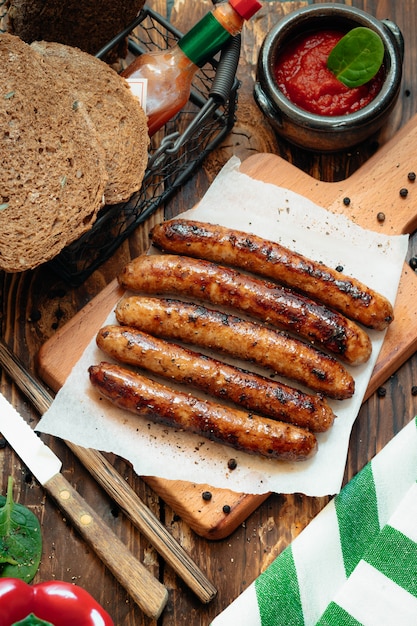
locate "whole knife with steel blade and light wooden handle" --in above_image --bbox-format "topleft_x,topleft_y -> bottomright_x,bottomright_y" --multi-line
0,394 -> 168,619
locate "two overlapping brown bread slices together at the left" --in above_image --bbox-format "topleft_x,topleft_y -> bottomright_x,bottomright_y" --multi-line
0,33 -> 149,272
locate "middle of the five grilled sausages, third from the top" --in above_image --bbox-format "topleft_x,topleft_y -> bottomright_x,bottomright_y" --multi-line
116,296 -> 355,400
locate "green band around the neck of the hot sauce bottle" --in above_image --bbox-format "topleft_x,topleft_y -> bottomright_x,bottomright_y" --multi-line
178,13 -> 231,66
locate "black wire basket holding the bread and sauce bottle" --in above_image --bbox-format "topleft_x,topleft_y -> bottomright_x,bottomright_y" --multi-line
37,7 -> 240,286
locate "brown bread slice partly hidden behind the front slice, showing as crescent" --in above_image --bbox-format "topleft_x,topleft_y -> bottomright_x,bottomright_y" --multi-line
31,41 -> 149,204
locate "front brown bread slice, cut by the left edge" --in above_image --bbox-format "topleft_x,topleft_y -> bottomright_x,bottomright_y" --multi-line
0,33 -> 107,272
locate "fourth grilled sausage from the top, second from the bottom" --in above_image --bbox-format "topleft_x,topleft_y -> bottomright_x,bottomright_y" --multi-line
96,325 -> 335,432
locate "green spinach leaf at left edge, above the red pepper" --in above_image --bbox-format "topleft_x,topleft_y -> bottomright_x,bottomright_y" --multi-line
0,476 -> 42,582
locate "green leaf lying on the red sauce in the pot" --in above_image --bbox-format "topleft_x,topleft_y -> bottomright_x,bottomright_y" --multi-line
327,26 -> 384,87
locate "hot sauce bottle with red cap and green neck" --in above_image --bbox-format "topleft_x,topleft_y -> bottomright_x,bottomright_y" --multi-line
122,0 -> 262,136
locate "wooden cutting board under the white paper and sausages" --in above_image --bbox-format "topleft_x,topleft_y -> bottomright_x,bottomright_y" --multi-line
38,116 -> 417,539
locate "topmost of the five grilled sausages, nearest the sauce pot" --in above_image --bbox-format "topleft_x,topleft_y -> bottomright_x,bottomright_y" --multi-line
150,219 -> 394,330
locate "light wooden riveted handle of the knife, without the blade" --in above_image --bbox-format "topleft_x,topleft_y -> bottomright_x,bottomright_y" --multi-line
43,474 -> 168,619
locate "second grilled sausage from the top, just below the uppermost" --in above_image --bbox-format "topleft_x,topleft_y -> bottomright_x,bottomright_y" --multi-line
119,254 -> 372,365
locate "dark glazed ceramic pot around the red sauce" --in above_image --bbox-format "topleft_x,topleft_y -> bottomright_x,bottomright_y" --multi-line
254,3 -> 404,152
